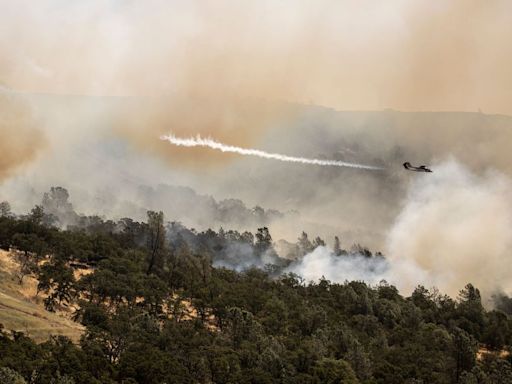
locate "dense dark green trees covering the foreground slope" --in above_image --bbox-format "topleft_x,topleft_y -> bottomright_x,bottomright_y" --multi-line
0,190 -> 512,384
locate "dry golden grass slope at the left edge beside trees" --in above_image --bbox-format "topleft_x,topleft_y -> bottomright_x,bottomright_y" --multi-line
0,251 -> 83,342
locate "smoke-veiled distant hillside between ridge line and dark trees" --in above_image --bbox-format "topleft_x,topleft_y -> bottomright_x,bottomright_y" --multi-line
4,94 -> 512,250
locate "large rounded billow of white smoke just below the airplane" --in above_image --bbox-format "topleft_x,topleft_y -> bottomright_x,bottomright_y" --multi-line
387,161 -> 512,295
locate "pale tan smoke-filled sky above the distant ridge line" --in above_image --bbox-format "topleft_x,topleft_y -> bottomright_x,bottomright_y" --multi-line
0,0 -> 512,114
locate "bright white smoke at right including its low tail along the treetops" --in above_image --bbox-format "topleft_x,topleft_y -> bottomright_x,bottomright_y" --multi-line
289,161 -> 512,298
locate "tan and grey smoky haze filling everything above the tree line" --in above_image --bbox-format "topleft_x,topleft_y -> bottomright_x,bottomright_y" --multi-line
0,0 -> 512,292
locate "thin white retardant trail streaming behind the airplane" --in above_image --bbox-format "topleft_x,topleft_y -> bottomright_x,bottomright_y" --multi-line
160,134 -> 383,171
